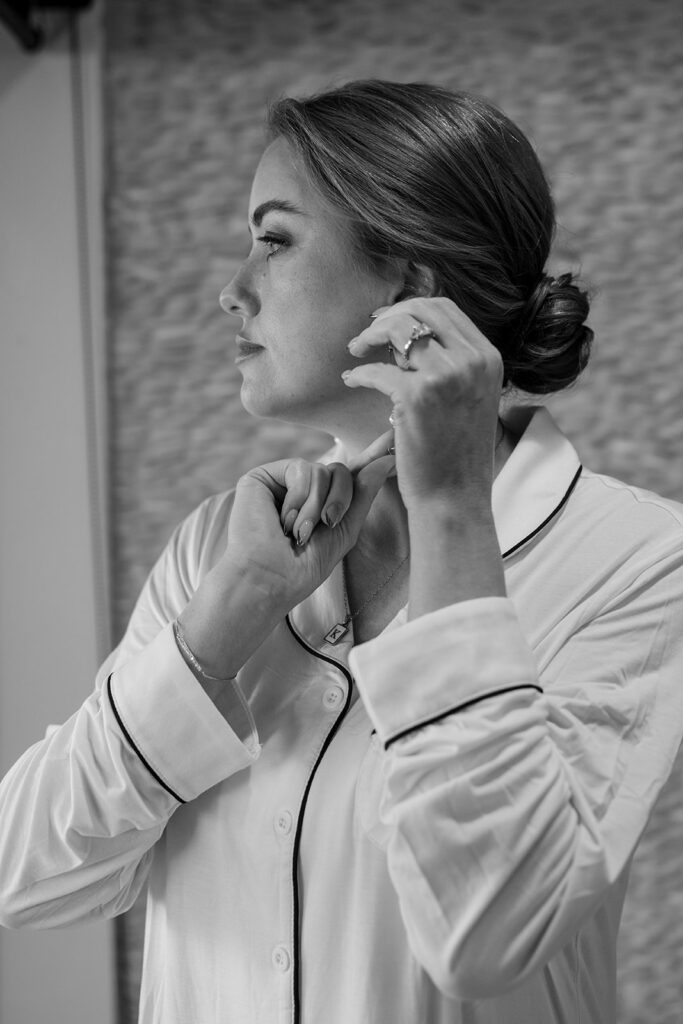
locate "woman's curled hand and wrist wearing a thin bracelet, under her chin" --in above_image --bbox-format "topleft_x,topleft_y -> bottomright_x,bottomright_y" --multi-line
179,431 -> 395,679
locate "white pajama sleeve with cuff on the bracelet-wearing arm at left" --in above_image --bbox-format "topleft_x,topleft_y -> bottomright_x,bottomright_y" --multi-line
0,491 -> 259,927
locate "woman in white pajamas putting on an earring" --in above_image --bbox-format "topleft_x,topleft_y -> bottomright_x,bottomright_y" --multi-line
0,82 -> 683,1024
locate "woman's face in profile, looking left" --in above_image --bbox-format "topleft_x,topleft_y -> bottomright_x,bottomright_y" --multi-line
220,138 -> 402,435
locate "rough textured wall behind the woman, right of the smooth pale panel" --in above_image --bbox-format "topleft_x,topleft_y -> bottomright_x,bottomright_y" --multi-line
105,0 -> 683,1024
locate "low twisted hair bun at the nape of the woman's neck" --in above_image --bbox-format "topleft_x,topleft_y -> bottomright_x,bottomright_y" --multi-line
505,273 -> 593,394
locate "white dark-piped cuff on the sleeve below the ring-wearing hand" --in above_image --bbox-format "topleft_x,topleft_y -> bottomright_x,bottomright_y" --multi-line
349,597 -> 541,745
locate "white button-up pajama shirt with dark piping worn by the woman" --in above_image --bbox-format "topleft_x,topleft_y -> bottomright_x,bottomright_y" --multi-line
0,409 -> 683,1024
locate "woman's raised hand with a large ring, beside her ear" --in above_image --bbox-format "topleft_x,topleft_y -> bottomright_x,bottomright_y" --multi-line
342,297 -> 503,512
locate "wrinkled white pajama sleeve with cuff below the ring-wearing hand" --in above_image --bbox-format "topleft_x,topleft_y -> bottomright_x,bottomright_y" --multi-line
351,534 -> 683,999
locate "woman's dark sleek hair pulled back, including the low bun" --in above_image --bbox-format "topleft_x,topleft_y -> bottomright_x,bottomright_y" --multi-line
268,80 -> 593,394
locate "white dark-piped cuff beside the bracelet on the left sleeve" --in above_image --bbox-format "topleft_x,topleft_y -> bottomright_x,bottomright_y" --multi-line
110,623 -> 260,801
